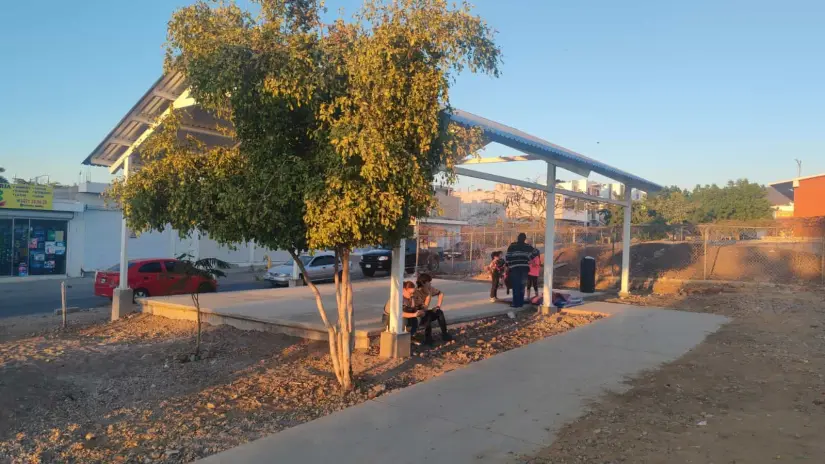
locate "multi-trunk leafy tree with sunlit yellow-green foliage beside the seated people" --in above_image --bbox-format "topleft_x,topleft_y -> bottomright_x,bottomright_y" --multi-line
107,0 -> 500,389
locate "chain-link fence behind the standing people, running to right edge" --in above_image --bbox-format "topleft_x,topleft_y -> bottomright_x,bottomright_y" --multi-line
418,219 -> 825,288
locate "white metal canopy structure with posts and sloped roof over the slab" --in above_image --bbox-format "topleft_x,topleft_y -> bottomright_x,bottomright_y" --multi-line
83,73 -> 662,358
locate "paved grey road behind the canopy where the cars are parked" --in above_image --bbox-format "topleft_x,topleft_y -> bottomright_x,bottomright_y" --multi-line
0,268 -> 364,318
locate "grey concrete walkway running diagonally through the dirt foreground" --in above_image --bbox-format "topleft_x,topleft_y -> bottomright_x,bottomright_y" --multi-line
200,302 -> 727,464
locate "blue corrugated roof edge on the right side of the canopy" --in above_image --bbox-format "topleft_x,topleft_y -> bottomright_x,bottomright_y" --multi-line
448,109 -> 662,193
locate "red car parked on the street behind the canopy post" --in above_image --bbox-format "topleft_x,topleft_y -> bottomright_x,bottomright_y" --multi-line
95,258 -> 218,298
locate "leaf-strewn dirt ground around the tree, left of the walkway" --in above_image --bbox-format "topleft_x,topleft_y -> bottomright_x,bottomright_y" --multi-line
0,311 -> 595,463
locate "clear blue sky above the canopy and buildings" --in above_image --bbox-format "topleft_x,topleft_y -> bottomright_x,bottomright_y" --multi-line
0,0 -> 825,187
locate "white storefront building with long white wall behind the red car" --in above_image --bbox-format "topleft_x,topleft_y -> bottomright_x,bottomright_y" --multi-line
0,182 -> 289,278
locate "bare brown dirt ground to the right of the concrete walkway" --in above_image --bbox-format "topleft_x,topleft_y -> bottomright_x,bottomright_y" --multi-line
529,287 -> 825,464
